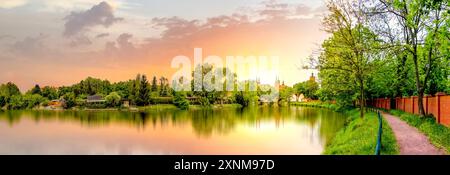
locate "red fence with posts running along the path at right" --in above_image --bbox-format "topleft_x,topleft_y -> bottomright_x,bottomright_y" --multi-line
368,93 -> 450,126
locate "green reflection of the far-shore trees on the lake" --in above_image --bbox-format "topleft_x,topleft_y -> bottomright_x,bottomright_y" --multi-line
0,107 -> 345,141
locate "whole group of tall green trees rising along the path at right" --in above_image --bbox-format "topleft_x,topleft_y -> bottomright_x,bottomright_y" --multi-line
311,0 -> 450,117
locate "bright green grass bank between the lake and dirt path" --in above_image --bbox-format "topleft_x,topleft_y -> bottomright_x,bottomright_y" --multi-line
323,109 -> 399,155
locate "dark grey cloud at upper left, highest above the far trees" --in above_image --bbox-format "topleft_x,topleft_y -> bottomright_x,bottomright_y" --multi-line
63,1 -> 123,37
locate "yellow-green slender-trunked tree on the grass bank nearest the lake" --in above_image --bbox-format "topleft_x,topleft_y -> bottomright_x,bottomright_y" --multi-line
319,1 -> 378,117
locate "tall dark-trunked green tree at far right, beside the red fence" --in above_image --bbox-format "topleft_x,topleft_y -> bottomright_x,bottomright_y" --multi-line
373,0 -> 450,116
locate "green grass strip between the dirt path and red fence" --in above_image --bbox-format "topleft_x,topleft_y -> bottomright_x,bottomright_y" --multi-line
389,110 -> 450,154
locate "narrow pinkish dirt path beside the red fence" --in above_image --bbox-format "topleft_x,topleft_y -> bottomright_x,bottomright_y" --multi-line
383,113 -> 444,155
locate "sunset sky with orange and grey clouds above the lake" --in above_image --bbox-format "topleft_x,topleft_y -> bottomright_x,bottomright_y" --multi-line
0,0 -> 327,91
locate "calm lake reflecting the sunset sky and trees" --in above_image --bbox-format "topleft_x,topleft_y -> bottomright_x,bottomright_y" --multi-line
0,106 -> 346,155
